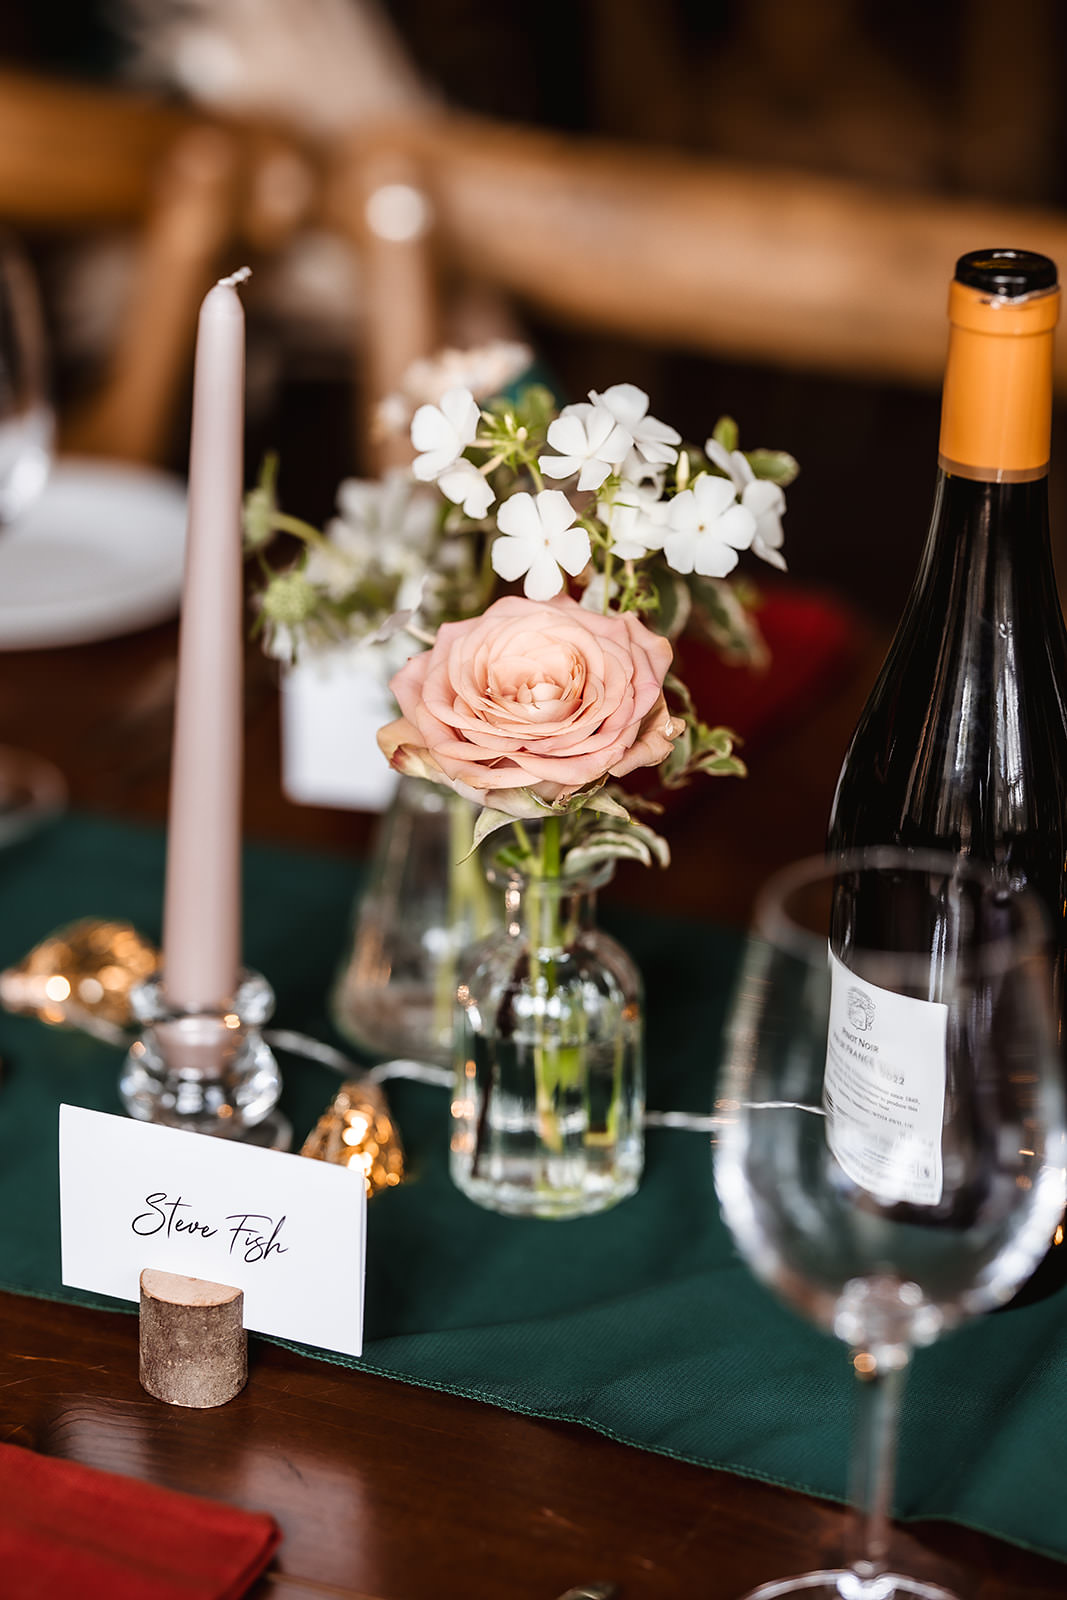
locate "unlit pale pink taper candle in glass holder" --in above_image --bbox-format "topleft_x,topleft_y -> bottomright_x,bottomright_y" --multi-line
163,269 -> 248,1011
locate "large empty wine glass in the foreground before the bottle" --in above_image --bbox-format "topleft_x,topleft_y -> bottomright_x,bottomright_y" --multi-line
715,848 -> 1067,1600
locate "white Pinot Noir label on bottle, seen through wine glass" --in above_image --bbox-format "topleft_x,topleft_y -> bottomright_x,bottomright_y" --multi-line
822,950 -> 949,1205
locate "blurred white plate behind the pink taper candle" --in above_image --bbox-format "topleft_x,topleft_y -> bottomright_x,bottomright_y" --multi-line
0,461 -> 186,650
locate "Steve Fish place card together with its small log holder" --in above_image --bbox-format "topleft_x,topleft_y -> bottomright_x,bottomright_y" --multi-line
59,1106 -> 366,1406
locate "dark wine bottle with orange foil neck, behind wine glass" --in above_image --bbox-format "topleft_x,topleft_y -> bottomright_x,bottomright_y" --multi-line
829,250 -> 1067,1298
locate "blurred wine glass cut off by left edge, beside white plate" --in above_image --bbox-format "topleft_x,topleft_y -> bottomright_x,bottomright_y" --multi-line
0,229 -> 66,846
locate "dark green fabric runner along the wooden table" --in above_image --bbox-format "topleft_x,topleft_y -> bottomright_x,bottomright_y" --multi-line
0,818 -> 1067,1560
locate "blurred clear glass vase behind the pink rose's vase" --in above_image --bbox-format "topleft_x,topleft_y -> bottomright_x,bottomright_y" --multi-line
330,778 -> 501,1066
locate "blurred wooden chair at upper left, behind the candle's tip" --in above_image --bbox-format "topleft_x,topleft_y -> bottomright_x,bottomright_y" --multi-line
0,72 -> 317,464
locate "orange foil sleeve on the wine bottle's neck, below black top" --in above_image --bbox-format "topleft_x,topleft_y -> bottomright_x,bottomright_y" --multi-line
939,283 -> 1059,483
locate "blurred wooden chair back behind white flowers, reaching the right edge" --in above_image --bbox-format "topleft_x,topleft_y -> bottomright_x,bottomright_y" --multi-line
326,115 -> 1067,464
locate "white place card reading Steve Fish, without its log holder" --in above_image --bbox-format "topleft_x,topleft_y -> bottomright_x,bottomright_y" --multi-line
59,1106 -> 366,1355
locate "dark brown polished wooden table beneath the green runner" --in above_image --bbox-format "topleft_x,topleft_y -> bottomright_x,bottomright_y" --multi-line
0,627 -> 1067,1600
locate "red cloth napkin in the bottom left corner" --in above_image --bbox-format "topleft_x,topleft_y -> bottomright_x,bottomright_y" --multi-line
0,1445 -> 282,1600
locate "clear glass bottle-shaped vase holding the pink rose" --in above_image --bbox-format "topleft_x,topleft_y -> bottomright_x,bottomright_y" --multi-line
451,862 -> 645,1218
